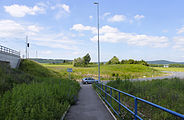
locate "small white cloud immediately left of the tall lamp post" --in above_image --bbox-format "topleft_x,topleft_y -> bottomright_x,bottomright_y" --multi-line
71,24 -> 97,33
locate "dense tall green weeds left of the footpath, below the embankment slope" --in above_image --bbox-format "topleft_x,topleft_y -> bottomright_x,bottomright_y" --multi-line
0,79 -> 80,120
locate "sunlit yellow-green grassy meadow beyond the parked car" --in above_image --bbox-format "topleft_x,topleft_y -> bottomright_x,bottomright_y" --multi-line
43,64 -> 163,80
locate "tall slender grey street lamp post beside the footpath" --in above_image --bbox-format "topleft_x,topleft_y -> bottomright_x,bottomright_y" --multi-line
94,2 -> 100,82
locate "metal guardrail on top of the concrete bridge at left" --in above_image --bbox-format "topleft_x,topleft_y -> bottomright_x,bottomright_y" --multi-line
0,45 -> 20,56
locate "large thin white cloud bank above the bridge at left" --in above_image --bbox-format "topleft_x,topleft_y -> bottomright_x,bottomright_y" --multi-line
0,20 -> 79,50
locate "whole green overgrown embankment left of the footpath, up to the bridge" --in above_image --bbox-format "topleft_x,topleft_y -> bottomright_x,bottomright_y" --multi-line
0,60 -> 80,120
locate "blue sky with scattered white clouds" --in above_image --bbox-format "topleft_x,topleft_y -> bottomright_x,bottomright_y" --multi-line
0,0 -> 184,62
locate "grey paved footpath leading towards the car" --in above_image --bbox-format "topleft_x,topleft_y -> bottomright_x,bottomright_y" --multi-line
65,85 -> 114,120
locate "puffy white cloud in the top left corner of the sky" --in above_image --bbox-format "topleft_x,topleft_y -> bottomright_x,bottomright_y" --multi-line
4,4 -> 45,17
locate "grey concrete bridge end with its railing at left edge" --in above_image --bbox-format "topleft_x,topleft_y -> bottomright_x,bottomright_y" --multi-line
0,45 -> 21,68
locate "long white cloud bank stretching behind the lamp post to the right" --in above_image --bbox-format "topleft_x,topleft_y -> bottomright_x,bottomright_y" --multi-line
72,24 -> 169,47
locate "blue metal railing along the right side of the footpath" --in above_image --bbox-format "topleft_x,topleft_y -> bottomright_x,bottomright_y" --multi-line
95,83 -> 184,120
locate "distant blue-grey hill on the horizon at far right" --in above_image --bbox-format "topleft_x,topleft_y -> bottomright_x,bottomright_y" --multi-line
146,60 -> 184,64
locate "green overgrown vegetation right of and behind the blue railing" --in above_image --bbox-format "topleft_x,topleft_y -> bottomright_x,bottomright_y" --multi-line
98,78 -> 184,120
